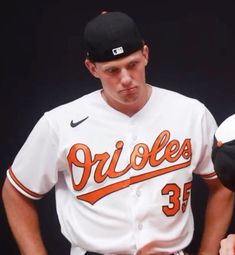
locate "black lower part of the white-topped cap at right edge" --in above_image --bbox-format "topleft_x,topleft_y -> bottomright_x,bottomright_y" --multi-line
212,138 -> 235,191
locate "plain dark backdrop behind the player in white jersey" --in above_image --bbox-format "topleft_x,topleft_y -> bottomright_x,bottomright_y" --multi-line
0,0 -> 235,255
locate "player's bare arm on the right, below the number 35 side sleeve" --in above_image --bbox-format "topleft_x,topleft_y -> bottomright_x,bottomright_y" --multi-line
198,179 -> 234,255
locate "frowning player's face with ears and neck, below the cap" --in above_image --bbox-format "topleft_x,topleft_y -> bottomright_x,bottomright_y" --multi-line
85,45 -> 148,114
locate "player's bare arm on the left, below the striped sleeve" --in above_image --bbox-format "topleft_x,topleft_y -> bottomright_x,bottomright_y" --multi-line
2,178 -> 47,255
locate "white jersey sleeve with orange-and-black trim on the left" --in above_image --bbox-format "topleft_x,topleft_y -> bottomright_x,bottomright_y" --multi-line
7,115 -> 58,199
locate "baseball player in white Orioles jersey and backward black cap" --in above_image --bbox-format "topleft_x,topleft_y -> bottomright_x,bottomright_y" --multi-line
3,12 -> 233,255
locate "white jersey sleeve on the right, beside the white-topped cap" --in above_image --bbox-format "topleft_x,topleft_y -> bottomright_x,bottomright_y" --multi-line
194,107 -> 218,179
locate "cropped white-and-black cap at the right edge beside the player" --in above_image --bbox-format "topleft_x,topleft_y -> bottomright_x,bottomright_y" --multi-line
212,114 -> 235,191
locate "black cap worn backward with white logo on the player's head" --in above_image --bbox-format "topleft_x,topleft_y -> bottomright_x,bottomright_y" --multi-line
84,12 -> 144,62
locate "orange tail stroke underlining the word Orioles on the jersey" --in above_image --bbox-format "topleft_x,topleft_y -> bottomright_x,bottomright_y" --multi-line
77,160 -> 191,204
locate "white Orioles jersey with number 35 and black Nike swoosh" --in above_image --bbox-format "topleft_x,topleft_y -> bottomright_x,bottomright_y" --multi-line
7,87 -> 217,255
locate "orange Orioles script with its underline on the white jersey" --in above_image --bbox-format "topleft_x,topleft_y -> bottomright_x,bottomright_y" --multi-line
67,130 -> 192,204
